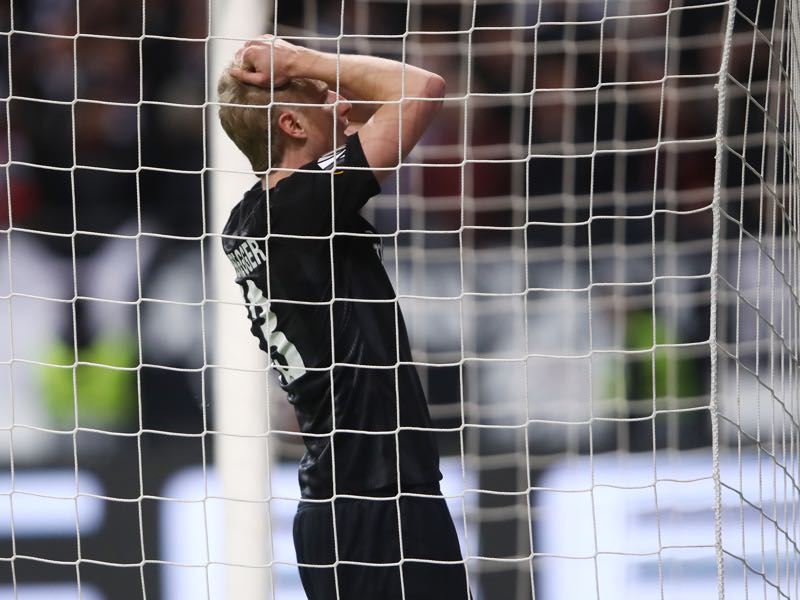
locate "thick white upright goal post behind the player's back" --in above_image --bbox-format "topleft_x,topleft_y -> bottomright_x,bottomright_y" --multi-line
207,0 -> 272,600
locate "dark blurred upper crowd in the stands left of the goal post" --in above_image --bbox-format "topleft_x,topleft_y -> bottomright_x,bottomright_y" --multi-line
3,0 -> 207,244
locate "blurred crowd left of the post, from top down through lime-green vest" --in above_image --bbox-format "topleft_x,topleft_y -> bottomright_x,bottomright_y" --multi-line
0,0 -> 208,447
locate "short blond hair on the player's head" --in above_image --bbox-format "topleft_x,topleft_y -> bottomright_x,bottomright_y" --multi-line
217,67 -> 316,173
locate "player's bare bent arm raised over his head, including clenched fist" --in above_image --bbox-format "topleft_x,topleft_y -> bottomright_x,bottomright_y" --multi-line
231,36 -> 445,180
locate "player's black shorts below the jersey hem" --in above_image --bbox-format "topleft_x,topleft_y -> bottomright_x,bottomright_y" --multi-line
294,484 -> 470,600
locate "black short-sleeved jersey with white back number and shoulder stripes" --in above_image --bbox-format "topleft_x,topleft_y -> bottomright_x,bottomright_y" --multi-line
222,135 -> 441,498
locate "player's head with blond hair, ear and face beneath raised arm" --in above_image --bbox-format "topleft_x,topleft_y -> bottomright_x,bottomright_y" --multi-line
217,69 -> 351,173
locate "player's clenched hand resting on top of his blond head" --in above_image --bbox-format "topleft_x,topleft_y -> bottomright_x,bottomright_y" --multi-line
230,34 -> 299,88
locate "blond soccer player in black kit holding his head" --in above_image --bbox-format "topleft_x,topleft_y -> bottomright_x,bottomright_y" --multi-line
219,36 -> 469,600
